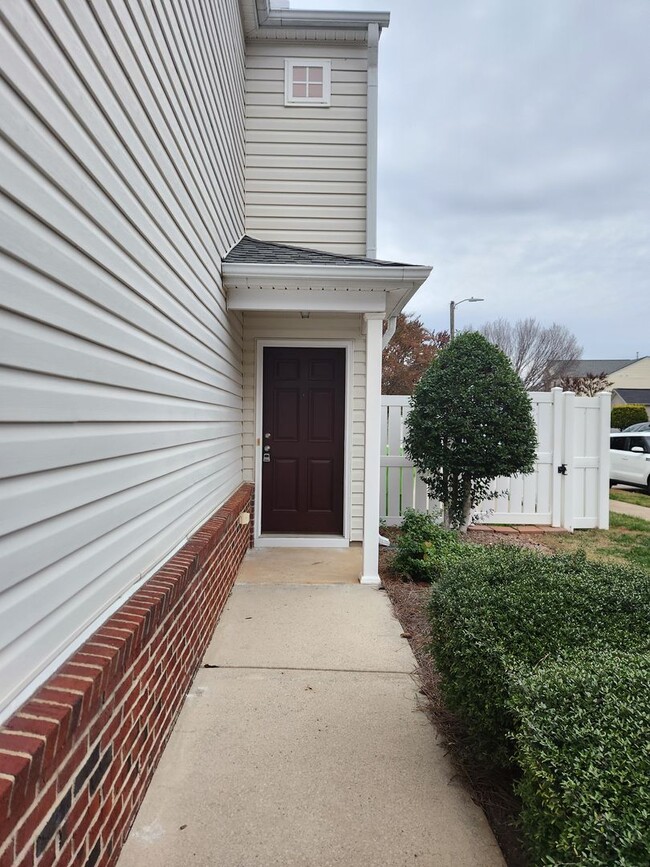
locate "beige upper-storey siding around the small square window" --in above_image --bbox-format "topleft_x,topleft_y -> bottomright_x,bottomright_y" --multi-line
246,42 -> 367,255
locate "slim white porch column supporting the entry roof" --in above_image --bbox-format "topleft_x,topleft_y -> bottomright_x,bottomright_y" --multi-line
360,313 -> 384,585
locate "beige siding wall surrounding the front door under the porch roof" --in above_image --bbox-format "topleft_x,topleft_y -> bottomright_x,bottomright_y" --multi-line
244,312 -> 366,542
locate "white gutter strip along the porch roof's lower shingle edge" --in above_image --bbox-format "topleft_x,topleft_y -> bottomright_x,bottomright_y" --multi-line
222,262 -> 431,292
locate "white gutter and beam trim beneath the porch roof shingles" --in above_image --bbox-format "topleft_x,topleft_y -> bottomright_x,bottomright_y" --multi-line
222,262 -> 431,318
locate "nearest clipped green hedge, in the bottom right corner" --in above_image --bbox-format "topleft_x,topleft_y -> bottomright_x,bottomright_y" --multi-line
513,651 -> 650,867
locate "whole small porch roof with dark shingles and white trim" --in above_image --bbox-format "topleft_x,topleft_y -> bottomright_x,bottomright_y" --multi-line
222,235 -> 431,317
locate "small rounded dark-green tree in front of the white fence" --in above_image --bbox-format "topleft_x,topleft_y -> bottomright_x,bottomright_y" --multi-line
404,332 -> 537,532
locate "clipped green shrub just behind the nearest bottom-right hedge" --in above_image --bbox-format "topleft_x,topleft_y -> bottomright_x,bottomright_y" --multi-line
430,545 -> 650,765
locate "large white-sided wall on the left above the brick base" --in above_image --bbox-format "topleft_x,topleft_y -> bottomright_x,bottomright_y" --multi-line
0,0 -> 244,713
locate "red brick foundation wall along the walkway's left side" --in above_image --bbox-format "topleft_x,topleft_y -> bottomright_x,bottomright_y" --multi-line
0,485 -> 253,867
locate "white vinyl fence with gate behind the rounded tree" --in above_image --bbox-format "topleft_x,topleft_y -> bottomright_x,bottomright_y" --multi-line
380,388 -> 611,530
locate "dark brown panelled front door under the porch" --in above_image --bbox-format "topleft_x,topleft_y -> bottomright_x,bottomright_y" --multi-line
262,347 -> 345,534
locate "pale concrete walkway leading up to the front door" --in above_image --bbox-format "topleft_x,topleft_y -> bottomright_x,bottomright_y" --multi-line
119,549 -> 504,867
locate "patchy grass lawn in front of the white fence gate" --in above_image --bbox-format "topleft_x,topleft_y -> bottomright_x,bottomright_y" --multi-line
543,512 -> 650,571
